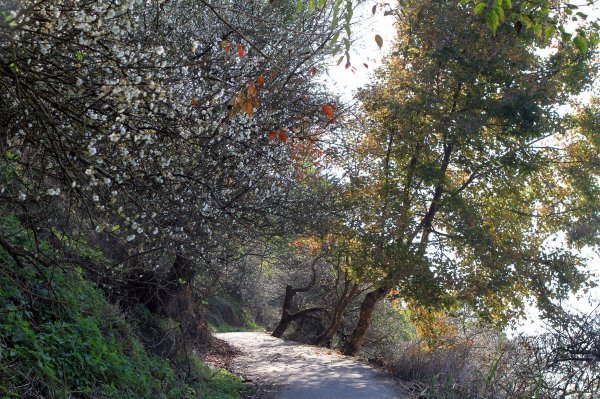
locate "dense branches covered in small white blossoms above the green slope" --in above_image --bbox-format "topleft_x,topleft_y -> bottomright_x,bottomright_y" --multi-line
0,0 -> 330,282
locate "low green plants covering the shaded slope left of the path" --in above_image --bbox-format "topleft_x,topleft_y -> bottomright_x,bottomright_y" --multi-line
0,215 -> 243,399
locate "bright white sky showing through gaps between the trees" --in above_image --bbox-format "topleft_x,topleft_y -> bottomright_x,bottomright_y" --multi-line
327,0 -> 600,334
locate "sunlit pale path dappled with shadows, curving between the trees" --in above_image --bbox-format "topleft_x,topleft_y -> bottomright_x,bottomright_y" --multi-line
216,332 -> 408,399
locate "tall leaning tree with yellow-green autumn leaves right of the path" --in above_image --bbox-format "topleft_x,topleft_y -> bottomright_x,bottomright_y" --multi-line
341,0 -> 599,355
